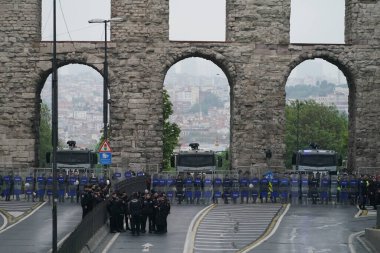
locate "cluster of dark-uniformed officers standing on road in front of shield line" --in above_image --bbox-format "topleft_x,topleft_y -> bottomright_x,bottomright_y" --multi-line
107,190 -> 170,235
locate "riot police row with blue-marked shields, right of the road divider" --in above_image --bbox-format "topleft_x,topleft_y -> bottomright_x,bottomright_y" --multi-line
152,172 -> 376,204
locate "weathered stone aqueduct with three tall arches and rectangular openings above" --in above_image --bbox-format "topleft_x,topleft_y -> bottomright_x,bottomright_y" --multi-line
0,0 -> 380,172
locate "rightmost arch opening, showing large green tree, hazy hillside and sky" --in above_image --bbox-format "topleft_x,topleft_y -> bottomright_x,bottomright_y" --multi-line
285,57 -> 355,170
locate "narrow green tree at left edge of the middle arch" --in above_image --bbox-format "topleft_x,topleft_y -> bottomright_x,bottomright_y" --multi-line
163,90 -> 181,170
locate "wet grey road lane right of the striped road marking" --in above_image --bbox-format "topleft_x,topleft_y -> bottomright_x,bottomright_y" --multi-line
249,205 -> 376,253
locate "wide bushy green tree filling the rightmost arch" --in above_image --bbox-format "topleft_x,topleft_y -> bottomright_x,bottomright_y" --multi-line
285,100 -> 348,168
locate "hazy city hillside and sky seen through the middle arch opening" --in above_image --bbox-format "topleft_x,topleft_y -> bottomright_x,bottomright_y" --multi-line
164,57 -> 231,170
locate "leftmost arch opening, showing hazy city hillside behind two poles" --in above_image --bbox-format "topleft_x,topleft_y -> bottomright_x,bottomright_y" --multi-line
36,64 -> 104,167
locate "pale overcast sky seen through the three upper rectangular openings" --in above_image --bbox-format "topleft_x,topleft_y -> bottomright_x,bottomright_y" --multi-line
42,0 -> 345,43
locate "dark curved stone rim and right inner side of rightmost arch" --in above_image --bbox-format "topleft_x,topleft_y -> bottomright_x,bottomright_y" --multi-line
282,51 -> 356,170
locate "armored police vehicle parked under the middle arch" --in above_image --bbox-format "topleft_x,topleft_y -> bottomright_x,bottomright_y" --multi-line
172,143 -> 222,173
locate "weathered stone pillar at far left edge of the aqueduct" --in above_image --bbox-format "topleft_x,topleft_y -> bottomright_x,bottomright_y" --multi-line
0,0 -> 41,166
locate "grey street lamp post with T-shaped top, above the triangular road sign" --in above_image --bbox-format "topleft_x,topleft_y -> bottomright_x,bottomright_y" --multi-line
88,18 -> 123,141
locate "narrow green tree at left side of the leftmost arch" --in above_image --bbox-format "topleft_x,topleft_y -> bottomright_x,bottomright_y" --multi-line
39,103 -> 53,167
